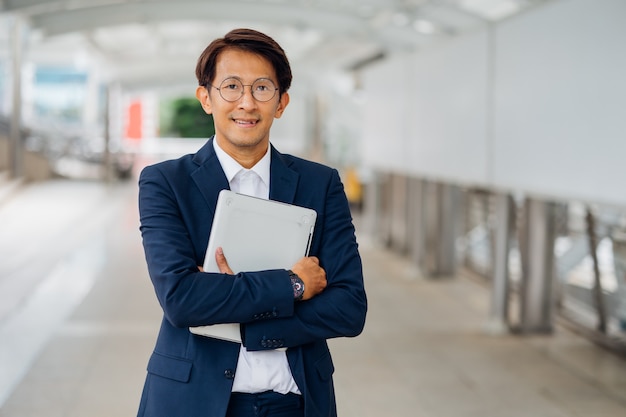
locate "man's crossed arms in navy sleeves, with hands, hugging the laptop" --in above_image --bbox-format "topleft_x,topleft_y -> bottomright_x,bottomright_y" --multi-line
140,164 -> 367,350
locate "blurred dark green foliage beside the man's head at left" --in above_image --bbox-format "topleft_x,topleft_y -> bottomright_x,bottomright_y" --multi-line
161,97 -> 215,138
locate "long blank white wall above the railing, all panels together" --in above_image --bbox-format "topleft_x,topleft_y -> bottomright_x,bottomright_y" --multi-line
363,0 -> 626,205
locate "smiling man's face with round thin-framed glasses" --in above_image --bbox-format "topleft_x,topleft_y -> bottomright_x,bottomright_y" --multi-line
196,49 -> 289,159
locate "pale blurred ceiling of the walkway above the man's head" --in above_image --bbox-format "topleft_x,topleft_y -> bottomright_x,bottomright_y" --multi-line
0,0 -> 547,88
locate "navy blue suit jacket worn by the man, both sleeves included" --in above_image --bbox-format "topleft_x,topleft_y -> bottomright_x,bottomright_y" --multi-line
139,139 -> 367,417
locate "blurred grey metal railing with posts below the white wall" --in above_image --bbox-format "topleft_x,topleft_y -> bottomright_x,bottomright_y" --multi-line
364,172 -> 626,353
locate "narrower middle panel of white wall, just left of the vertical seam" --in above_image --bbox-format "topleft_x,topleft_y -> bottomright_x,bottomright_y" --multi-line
404,28 -> 488,183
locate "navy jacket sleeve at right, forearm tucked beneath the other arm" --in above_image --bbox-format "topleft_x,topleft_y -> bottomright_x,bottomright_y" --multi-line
243,170 -> 367,350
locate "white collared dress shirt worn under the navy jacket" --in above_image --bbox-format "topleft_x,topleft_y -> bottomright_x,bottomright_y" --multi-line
213,139 -> 300,394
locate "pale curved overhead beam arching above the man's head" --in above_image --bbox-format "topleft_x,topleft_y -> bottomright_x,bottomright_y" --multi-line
19,0 -> 422,48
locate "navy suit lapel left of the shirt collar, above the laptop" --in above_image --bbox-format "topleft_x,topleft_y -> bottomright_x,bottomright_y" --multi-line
191,138 -> 230,214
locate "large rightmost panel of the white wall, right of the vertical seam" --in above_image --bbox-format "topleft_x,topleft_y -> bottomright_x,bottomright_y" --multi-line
493,0 -> 626,204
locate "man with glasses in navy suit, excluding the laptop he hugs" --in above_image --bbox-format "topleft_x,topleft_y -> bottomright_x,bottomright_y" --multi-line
134,29 -> 367,417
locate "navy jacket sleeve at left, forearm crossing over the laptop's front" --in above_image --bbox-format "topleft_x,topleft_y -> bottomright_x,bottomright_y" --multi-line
139,164 -> 294,327
